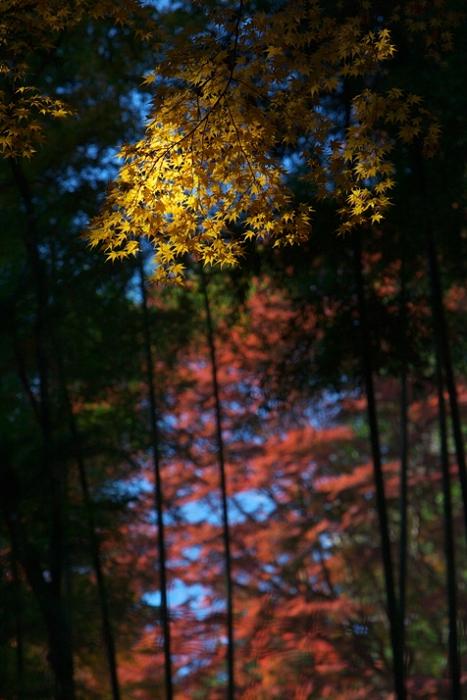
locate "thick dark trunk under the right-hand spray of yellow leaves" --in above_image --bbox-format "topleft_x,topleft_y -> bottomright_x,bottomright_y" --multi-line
353,231 -> 406,700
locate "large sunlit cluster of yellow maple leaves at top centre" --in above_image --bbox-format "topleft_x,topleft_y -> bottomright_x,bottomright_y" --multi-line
89,2 -> 402,282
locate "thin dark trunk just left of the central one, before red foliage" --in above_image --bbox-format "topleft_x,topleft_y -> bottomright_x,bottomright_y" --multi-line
139,256 -> 173,700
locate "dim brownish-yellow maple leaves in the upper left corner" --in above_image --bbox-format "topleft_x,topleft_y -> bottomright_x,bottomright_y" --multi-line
0,0 -> 157,158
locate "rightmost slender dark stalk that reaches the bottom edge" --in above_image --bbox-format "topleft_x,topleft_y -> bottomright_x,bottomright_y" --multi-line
436,353 -> 461,700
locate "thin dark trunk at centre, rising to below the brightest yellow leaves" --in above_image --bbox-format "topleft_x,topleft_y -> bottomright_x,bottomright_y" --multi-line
201,270 -> 235,700
